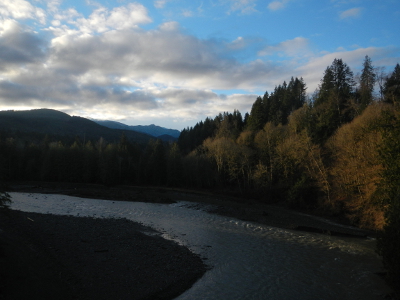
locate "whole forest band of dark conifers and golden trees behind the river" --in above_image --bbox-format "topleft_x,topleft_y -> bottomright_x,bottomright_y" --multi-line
0,56 -> 400,286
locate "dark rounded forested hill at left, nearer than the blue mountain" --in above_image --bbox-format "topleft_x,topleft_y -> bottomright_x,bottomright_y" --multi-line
0,109 -> 152,143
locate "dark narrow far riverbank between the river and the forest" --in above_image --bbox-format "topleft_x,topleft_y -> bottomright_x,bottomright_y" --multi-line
10,182 -> 377,238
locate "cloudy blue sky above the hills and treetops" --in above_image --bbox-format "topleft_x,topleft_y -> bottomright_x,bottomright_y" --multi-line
0,0 -> 400,130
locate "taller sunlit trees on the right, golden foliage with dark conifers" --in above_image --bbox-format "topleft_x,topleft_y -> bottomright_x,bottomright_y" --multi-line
178,56 -> 400,287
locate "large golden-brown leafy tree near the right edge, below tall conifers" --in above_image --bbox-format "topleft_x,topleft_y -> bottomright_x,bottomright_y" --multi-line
327,104 -> 384,229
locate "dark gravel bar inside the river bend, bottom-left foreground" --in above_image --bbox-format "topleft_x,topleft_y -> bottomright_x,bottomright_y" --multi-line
0,211 -> 206,299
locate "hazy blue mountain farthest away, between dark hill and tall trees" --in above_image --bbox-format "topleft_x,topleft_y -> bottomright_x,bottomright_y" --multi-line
93,120 -> 181,140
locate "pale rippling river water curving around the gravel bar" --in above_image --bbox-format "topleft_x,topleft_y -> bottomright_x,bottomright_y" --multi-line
10,193 -> 390,300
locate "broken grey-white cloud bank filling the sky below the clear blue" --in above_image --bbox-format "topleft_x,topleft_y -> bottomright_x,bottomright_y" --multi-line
0,0 -> 398,129
